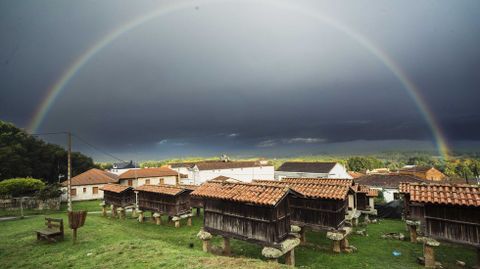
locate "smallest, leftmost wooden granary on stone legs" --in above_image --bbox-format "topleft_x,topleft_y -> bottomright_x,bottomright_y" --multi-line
101,183 -> 136,218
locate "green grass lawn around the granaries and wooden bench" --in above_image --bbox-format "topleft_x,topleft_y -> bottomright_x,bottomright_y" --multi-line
0,208 -> 476,269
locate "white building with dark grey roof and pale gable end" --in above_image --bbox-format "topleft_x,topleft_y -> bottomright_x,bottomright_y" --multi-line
275,162 -> 352,180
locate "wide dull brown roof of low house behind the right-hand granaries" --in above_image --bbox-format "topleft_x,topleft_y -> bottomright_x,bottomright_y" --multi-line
354,173 -> 426,189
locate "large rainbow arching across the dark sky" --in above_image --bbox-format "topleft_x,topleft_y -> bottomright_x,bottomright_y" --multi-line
27,0 -> 449,159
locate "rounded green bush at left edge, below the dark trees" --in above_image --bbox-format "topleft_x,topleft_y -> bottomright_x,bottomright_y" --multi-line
0,178 -> 45,197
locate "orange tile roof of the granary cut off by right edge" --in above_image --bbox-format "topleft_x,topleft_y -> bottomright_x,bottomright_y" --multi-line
400,183 -> 480,207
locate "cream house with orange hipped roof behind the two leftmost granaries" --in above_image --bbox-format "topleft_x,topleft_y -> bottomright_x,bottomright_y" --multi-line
118,167 -> 180,188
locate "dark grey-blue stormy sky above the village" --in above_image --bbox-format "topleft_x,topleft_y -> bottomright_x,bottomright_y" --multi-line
0,0 -> 480,160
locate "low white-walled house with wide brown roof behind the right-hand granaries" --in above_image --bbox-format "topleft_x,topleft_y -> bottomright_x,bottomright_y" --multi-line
355,174 -> 428,203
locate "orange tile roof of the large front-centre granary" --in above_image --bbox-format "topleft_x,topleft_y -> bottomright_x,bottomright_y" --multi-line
191,181 -> 290,206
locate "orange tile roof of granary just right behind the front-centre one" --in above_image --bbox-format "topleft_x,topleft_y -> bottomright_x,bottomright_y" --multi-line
254,180 -> 350,200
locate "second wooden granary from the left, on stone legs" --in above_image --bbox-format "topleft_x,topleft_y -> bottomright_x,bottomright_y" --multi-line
136,185 -> 192,228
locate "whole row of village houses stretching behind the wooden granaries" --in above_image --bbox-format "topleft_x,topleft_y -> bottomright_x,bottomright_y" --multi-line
62,156 -> 454,202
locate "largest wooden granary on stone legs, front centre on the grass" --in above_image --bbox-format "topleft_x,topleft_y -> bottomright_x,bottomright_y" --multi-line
191,181 -> 300,264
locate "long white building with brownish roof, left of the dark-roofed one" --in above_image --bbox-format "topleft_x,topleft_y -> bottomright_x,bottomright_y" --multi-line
170,160 -> 274,185
